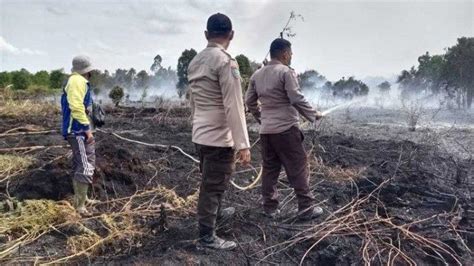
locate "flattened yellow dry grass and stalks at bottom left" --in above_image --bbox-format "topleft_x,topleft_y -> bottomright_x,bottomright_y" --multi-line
0,187 -> 198,264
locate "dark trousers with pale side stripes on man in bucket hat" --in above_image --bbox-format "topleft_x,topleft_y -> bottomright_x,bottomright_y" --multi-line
67,134 -> 95,184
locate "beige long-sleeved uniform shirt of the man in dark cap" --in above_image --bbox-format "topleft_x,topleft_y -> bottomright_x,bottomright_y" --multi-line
188,43 -> 248,149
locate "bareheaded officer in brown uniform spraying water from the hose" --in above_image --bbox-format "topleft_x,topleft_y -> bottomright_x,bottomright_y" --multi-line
246,38 -> 322,220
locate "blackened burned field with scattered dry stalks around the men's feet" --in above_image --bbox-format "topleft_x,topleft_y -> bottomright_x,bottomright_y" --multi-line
0,107 -> 474,265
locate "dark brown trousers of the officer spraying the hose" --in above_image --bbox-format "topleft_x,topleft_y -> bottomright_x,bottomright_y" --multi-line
260,126 -> 313,212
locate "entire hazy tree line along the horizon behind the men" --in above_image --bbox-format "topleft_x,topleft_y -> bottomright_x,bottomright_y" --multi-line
0,37 -> 474,108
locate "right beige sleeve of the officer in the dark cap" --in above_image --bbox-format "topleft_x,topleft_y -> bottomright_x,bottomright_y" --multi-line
219,59 -> 250,150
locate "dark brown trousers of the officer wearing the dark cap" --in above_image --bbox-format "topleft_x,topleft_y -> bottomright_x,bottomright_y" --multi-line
195,144 -> 235,237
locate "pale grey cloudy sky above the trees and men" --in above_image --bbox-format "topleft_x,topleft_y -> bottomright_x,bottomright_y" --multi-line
0,0 -> 474,80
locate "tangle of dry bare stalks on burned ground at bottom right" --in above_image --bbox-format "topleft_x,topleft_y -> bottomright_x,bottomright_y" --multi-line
252,180 -> 468,265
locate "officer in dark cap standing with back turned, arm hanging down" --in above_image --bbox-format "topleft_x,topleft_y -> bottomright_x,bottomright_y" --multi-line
188,13 -> 250,249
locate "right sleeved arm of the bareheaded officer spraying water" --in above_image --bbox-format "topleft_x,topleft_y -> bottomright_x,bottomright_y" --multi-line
284,70 -> 319,122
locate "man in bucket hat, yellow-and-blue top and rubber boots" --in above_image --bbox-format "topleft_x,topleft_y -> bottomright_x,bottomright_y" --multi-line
61,56 -> 95,215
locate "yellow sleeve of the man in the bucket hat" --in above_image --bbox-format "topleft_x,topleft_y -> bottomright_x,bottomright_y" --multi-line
66,79 -> 90,131
